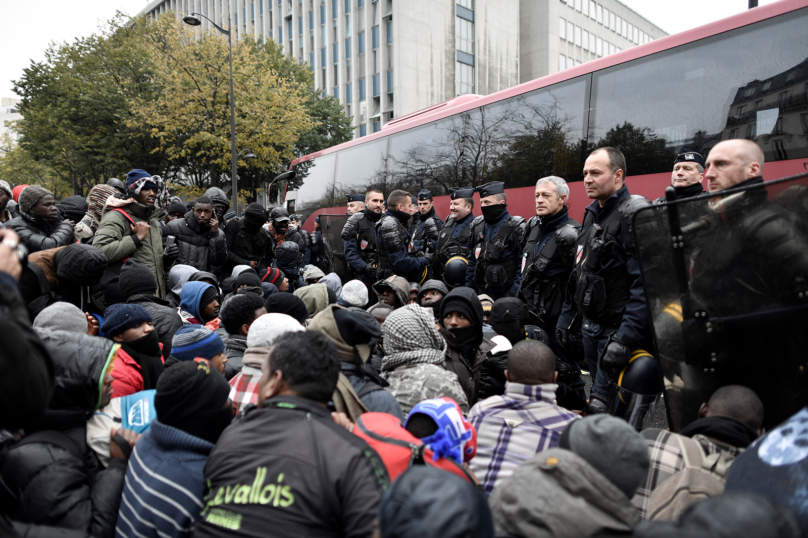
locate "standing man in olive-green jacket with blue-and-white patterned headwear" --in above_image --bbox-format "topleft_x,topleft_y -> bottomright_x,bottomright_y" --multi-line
93,169 -> 179,298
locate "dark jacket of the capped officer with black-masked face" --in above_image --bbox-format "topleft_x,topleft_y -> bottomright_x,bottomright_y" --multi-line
466,211 -> 527,295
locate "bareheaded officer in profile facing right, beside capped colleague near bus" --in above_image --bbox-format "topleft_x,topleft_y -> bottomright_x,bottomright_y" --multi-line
376,186 -> 433,284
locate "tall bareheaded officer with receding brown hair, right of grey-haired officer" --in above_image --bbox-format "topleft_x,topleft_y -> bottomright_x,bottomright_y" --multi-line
556,147 -> 650,413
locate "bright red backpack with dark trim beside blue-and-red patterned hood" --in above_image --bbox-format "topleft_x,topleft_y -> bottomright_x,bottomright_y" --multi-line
354,413 -> 475,485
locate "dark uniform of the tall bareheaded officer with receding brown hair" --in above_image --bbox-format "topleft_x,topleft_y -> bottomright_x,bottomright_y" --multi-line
557,185 -> 650,402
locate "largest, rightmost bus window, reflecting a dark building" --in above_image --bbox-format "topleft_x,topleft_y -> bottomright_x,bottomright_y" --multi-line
588,9 -> 808,175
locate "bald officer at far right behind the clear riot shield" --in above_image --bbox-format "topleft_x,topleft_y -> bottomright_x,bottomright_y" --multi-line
682,140 -> 808,428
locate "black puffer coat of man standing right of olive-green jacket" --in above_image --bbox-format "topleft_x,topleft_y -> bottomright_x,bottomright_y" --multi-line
164,211 -> 227,271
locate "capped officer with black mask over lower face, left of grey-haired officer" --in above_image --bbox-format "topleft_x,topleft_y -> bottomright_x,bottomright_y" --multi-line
466,181 -> 527,301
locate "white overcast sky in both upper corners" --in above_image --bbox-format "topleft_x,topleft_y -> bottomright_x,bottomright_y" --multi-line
0,0 -> 774,97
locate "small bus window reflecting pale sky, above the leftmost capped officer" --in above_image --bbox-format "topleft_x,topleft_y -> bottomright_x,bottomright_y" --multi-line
335,138 -> 387,198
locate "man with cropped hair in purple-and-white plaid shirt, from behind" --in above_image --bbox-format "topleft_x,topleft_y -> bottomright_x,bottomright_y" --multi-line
468,340 -> 580,495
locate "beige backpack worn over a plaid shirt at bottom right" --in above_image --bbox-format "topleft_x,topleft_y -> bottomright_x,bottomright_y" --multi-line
647,434 -> 732,521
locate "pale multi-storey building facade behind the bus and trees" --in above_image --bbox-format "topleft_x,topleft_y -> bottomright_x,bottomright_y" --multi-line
141,0 -> 666,136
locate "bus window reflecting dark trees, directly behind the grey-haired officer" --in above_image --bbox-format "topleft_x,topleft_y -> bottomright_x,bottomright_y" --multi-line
466,75 -> 590,188
